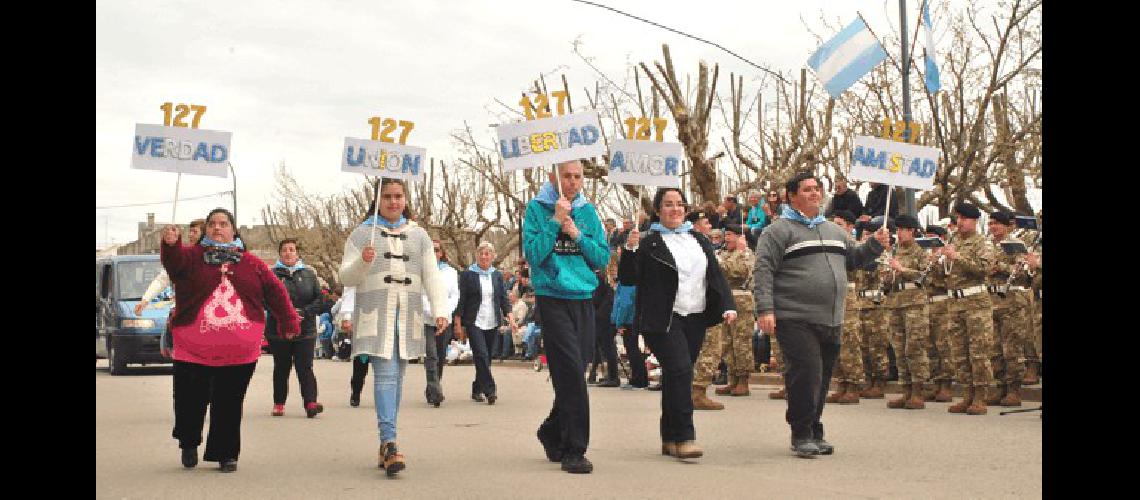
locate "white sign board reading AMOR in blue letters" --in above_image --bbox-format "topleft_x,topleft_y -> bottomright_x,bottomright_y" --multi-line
606,139 -> 685,188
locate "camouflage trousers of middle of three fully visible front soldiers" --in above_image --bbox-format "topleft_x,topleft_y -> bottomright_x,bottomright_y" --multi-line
946,293 -> 994,387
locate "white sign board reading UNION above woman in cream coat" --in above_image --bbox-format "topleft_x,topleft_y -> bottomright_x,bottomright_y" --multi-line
341,137 -> 428,181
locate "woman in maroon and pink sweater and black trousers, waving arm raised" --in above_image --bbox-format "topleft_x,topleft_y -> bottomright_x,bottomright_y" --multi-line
161,208 -> 311,473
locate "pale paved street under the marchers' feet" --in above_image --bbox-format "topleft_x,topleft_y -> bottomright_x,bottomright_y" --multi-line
95,355 -> 1042,499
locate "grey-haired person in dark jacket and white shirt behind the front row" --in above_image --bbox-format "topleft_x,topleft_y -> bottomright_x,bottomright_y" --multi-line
453,241 -> 511,404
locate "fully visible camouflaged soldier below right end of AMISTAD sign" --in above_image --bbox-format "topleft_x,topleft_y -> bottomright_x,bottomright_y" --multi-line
884,214 -> 930,410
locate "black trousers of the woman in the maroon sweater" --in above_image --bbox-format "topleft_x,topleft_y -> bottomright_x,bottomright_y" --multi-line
171,361 -> 258,461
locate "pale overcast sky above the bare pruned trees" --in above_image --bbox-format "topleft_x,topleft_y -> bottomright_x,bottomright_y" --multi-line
95,0 -> 980,247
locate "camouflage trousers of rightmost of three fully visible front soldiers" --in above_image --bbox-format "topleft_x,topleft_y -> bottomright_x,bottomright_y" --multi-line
991,290 -> 1032,384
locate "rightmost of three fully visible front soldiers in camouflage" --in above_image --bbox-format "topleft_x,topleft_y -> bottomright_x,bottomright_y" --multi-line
986,211 -> 1033,407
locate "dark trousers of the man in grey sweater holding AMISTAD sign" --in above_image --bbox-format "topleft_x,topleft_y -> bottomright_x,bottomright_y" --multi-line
776,319 -> 842,440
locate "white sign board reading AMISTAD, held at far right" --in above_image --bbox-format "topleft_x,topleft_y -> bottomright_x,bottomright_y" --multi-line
849,136 -> 942,189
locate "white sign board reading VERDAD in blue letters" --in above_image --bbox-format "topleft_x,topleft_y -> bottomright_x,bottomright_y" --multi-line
131,123 -> 231,179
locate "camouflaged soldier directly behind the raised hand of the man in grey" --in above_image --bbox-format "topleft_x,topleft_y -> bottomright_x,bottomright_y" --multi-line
857,222 -> 894,400
